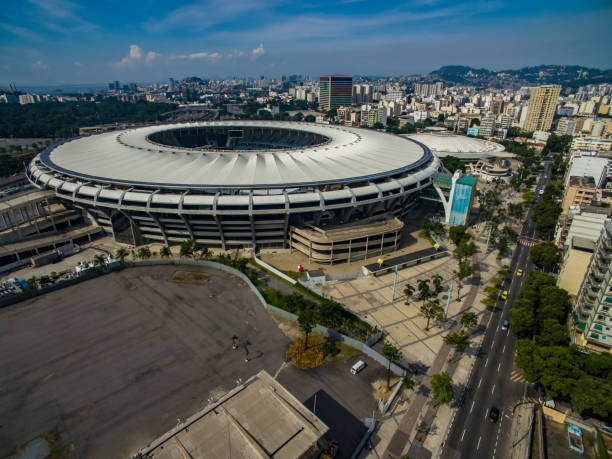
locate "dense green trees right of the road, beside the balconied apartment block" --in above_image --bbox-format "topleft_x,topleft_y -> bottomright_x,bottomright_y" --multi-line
510,271 -> 612,418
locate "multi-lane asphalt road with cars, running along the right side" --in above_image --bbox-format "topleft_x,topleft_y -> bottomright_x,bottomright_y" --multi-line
442,162 -> 551,458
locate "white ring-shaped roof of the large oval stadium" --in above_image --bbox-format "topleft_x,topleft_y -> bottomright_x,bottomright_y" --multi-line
40,121 -> 430,188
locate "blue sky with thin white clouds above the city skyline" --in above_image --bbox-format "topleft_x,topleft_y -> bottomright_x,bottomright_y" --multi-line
0,0 -> 612,86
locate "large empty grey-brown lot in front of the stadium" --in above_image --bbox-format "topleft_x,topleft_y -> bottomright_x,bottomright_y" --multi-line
0,266 -> 289,458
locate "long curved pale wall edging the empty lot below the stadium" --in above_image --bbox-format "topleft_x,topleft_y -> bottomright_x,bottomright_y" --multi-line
0,258 -> 406,376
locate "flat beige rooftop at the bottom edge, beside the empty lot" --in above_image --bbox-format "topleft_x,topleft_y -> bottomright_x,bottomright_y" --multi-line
139,371 -> 329,459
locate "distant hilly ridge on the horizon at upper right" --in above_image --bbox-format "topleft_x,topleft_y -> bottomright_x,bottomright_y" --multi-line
424,65 -> 612,87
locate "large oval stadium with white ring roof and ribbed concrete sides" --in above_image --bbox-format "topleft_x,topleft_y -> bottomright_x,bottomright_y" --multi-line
27,121 -> 441,262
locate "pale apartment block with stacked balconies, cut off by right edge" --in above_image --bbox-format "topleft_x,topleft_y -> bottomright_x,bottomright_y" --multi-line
572,221 -> 612,349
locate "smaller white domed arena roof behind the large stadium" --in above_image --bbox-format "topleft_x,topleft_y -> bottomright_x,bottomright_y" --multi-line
405,133 -> 514,159
